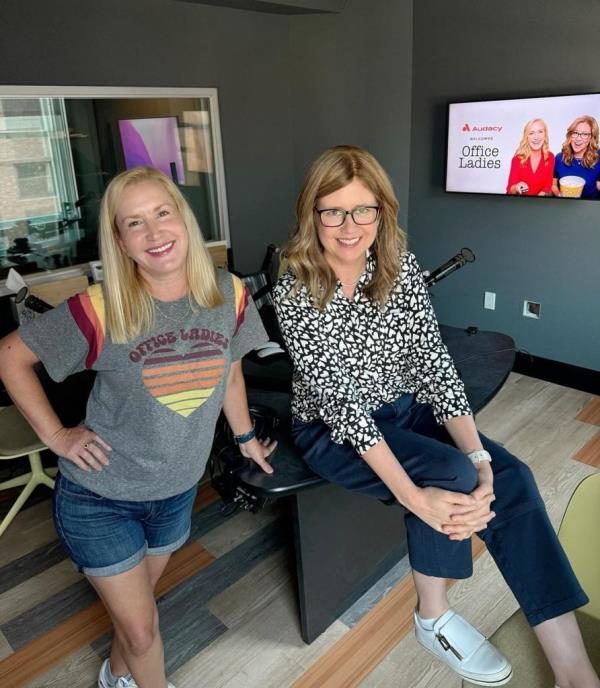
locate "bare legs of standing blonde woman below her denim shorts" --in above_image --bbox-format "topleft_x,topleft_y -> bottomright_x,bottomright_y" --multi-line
89,557 -> 167,688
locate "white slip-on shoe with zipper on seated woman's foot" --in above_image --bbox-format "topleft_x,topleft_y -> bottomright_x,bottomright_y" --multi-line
414,609 -> 512,686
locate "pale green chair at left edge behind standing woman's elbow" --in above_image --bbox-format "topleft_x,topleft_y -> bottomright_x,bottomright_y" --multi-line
0,406 -> 57,535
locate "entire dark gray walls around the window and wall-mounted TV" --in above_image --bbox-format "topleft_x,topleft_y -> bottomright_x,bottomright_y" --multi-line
0,0 -> 600,368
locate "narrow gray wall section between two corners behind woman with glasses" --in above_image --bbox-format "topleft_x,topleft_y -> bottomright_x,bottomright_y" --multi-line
290,0 -> 412,227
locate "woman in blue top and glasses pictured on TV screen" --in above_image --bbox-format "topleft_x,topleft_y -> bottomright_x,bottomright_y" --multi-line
552,115 -> 600,199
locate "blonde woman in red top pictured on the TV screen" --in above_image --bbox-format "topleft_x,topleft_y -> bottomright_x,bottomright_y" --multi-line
506,117 -> 554,196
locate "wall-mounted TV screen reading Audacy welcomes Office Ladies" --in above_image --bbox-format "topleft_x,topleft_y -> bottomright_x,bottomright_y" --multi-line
446,94 -> 600,200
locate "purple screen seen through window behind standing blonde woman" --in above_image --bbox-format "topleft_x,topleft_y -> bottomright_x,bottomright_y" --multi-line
119,117 -> 185,184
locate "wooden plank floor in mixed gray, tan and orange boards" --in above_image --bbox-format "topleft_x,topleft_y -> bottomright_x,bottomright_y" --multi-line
0,374 -> 600,688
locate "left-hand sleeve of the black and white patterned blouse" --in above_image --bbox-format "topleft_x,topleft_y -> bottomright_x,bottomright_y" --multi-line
273,282 -> 382,454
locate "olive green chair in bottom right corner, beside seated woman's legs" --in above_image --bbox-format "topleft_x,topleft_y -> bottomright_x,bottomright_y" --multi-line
463,473 -> 600,688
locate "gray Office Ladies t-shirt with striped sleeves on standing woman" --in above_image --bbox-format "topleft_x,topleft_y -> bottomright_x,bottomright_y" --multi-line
19,271 -> 266,501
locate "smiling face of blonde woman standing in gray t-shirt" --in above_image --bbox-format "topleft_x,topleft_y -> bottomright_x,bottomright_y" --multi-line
116,180 -> 188,293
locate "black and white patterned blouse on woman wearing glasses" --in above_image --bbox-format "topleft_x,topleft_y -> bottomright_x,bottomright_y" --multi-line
273,252 -> 471,454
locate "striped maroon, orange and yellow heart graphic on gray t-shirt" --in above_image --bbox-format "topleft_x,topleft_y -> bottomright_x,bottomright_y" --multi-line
142,342 -> 225,418
